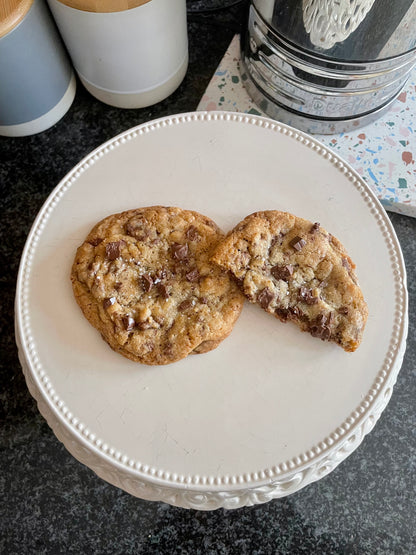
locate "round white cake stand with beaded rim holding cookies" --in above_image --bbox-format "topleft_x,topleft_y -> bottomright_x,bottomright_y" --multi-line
16,112 -> 407,509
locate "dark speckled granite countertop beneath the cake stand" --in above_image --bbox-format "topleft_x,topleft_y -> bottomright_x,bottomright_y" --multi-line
0,0 -> 416,554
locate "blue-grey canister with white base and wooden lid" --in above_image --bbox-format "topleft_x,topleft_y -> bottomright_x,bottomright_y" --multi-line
0,0 -> 76,137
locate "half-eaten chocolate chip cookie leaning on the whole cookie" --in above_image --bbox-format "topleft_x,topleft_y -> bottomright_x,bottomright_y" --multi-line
211,210 -> 368,351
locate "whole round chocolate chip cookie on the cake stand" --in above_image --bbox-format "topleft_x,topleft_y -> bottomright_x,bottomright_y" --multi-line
71,206 -> 244,364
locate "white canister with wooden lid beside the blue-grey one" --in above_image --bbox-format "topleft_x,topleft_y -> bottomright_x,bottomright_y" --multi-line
48,0 -> 188,108
